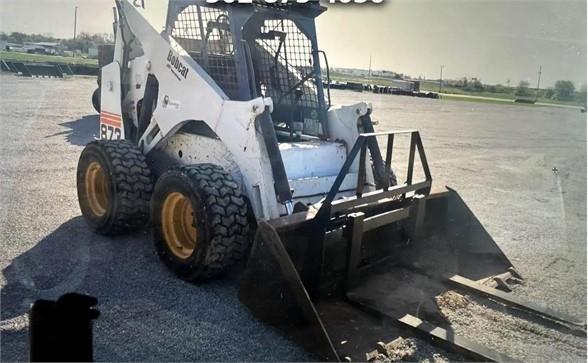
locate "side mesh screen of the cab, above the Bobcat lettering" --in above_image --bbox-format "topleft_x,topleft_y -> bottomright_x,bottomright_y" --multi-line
172,5 -> 238,99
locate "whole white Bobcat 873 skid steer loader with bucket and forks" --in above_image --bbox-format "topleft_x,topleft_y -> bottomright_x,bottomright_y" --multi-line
77,0 -> 584,360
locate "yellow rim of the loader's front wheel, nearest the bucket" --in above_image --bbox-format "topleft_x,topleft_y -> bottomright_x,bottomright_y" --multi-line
161,192 -> 198,259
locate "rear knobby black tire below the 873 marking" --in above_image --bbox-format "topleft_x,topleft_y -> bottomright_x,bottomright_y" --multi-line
77,140 -> 153,235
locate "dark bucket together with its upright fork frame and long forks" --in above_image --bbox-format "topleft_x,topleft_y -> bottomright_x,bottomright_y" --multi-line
239,131 -> 585,361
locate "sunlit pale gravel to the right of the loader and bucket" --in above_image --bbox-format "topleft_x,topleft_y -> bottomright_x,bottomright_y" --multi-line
334,87 -> 586,316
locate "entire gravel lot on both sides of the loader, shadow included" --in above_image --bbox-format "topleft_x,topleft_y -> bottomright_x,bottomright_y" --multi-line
0,75 -> 586,361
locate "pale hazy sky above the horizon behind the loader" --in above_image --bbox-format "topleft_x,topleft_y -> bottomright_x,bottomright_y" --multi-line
0,0 -> 586,86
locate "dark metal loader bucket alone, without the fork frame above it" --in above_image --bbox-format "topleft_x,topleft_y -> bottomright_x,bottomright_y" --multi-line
239,190 -> 512,360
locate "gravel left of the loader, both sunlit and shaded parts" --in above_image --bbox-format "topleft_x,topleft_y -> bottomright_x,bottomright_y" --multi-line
0,75 -> 307,361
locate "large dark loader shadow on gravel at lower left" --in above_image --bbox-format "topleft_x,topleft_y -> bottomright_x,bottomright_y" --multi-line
0,217 -> 308,361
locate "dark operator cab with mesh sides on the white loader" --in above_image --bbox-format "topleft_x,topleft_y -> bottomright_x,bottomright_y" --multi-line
166,0 -> 330,142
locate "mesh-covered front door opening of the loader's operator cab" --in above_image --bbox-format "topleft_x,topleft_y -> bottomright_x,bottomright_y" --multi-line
256,19 -> 318,108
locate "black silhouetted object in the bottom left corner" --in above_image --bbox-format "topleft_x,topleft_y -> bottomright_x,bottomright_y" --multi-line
29,293 -> 100,362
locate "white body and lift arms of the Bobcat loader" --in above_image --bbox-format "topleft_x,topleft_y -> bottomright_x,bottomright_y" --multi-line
100,0 -> 374,220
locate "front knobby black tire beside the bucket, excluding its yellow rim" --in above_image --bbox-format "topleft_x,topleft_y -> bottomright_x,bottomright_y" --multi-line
151,164 -> 251,282
